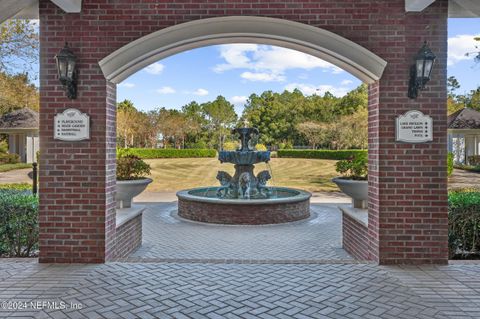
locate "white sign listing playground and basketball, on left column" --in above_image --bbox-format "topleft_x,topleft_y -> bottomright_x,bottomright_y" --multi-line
54,109 -> 90,142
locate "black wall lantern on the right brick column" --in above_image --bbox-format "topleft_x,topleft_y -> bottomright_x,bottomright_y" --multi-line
408,41 -> 436,99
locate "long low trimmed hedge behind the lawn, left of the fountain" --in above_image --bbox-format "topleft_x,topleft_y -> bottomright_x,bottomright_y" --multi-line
120,148 -> 217,159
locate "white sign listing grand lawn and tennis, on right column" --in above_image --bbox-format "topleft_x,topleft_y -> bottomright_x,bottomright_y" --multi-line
396,110 -> 433,143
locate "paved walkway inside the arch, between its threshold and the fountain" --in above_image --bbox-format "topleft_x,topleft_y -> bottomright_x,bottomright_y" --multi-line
124,203 -> 354,263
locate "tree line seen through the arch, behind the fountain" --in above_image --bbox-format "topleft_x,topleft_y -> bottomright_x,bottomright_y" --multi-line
117,84 -> 368,150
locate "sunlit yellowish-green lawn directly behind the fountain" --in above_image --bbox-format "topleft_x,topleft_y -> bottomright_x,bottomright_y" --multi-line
146,158 -> 338,192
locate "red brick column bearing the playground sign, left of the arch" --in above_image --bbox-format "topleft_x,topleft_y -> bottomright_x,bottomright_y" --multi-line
39,0 -> 116,263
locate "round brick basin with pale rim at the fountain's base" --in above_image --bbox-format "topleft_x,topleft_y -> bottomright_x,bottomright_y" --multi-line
177,187 -> 312,225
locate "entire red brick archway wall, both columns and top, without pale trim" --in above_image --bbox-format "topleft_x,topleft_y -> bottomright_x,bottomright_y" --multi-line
40,0 -> 447,263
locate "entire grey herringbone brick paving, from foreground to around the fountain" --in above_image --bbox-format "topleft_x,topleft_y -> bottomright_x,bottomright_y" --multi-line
0,204 -> 480,319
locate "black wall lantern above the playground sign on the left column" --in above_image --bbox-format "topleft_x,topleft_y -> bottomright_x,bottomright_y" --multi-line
55,43 -> 77,100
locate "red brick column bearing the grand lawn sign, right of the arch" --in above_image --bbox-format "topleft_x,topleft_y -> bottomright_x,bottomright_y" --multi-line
369,1 -> 448,264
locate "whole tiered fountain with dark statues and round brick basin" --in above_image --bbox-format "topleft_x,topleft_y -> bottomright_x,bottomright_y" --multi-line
177,128 -> 311,225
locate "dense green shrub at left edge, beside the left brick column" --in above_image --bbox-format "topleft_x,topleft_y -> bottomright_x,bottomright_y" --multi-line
0,190 -> 38,257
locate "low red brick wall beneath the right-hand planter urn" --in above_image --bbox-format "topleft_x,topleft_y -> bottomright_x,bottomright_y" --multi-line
342,213 -> 372,260
